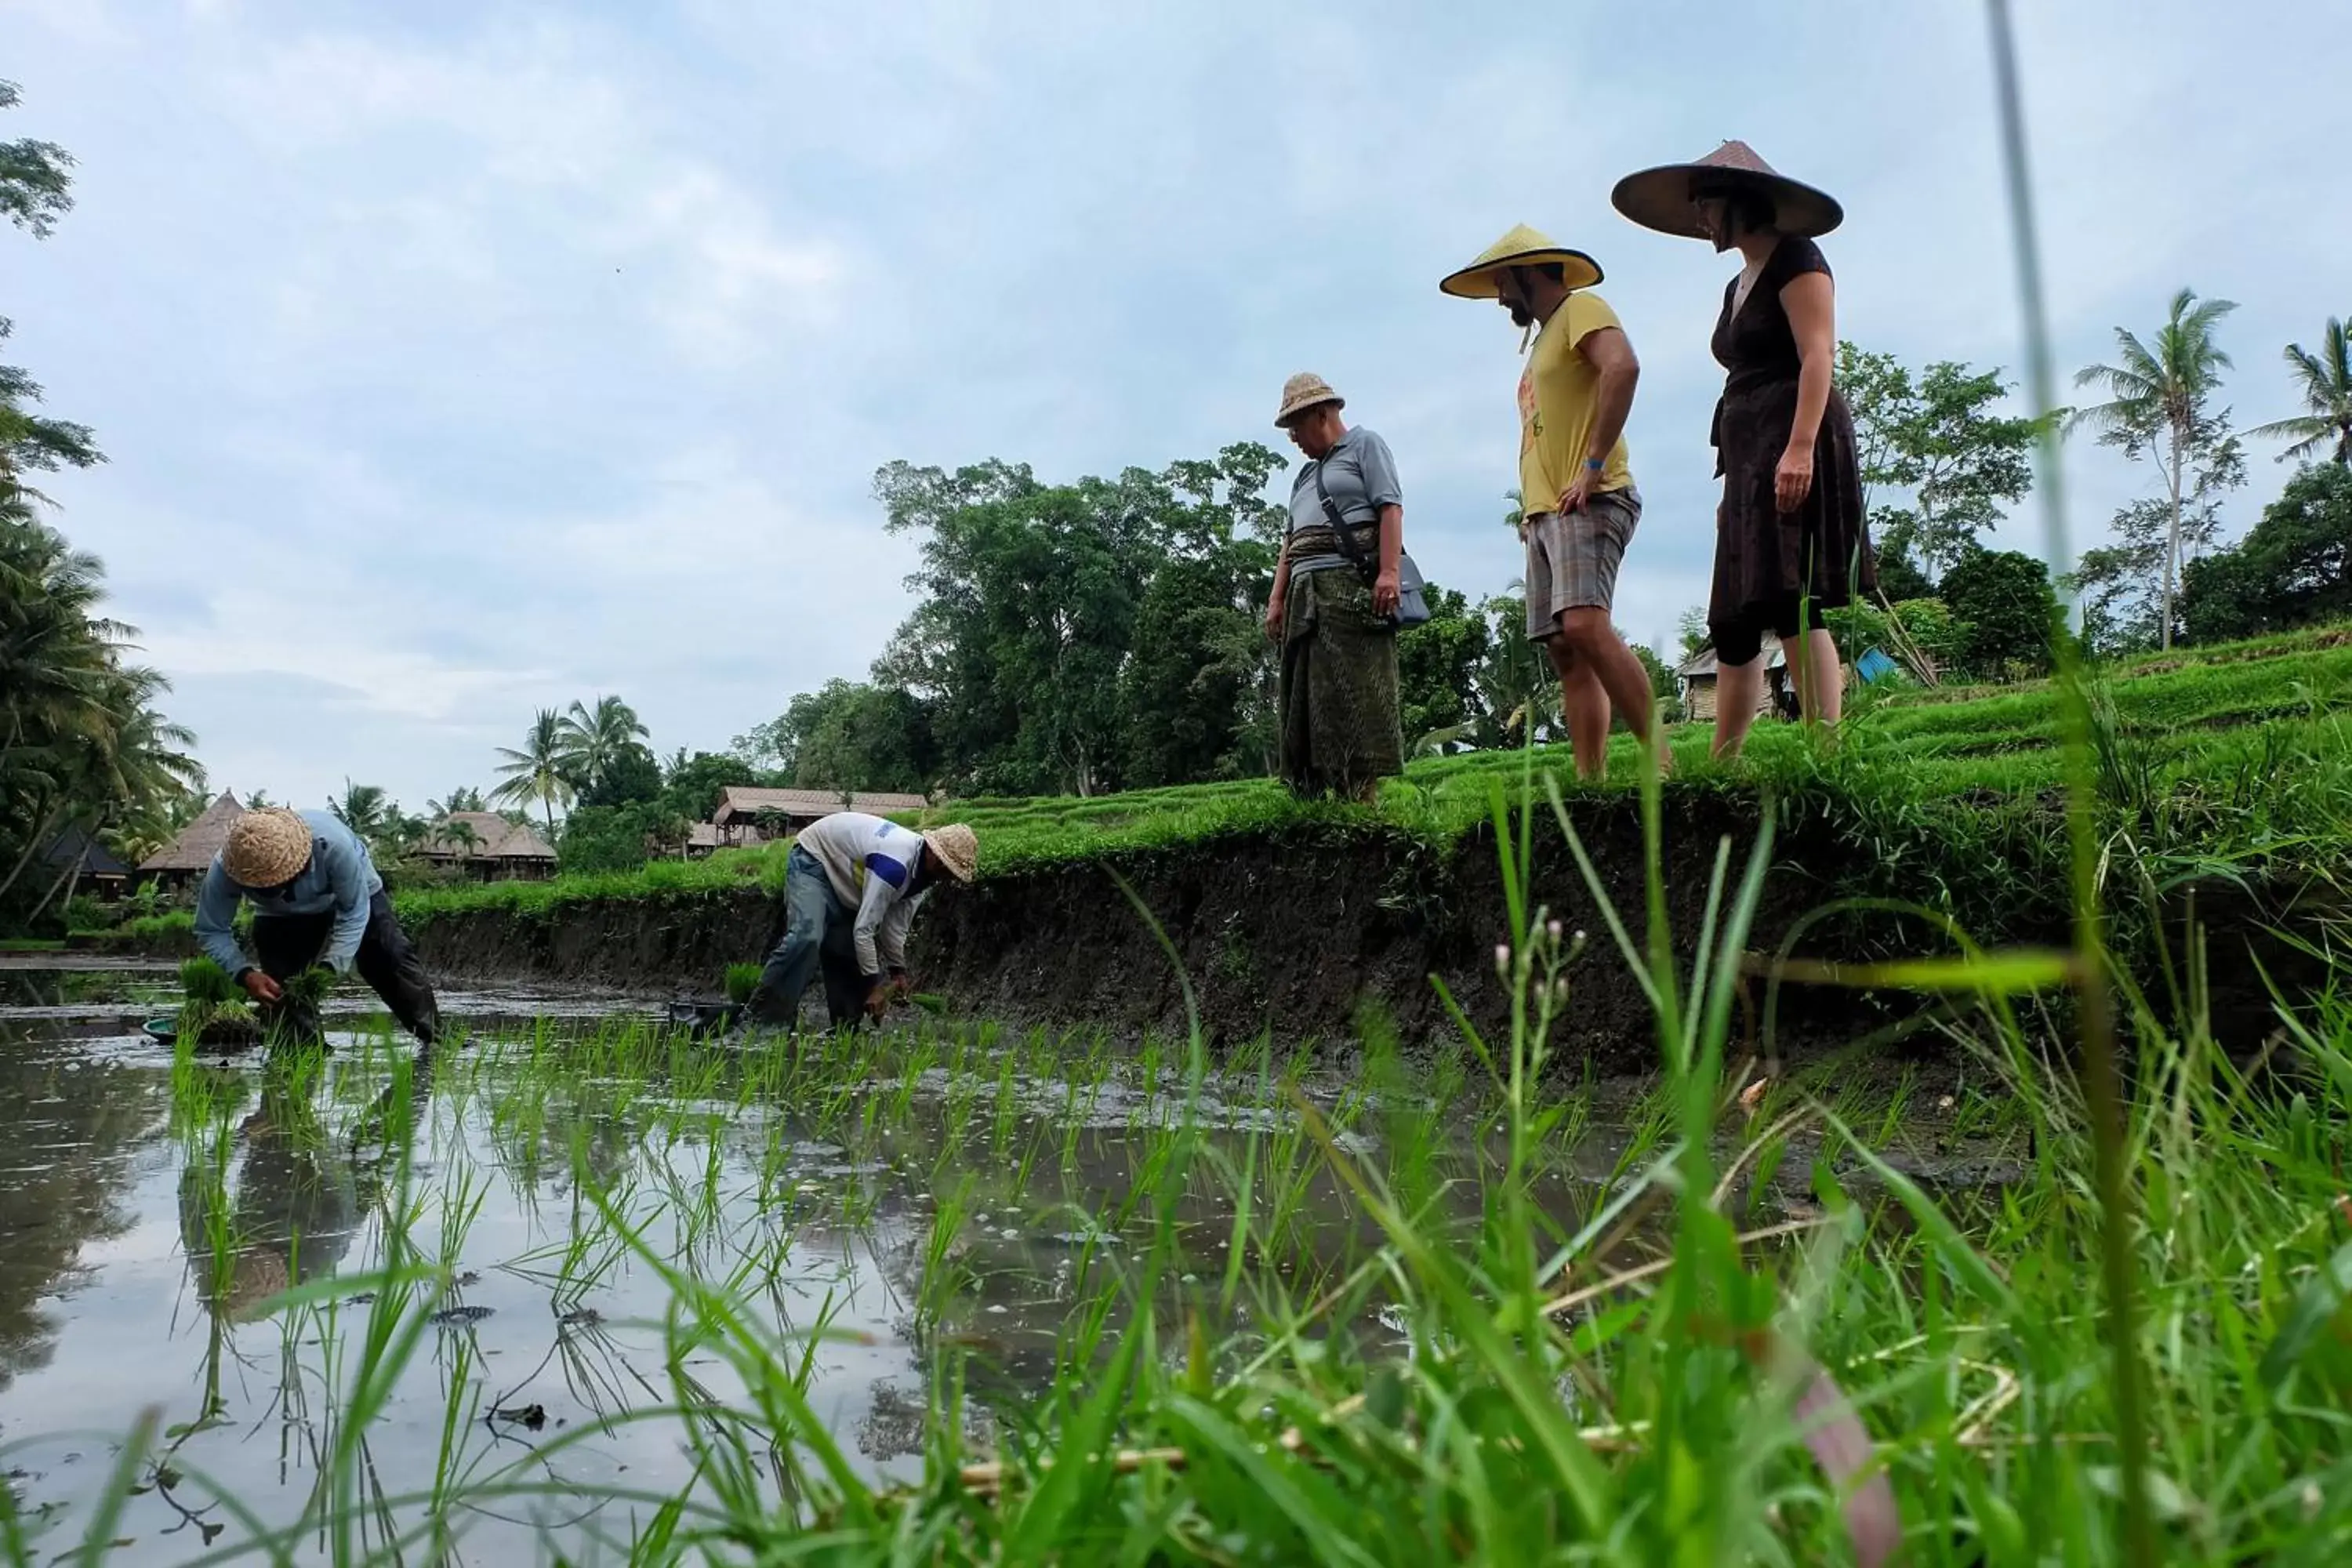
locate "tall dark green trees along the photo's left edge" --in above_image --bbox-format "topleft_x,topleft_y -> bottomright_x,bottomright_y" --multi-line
0,82 -> 205,931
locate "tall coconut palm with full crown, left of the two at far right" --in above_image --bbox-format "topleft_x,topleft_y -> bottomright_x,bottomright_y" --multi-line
2065,289 -> 2237,649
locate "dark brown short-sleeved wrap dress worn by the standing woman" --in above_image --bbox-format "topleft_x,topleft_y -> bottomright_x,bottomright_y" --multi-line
1708,235 -> 1877,663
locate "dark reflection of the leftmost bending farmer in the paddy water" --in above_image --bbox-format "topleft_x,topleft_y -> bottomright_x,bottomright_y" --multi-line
179,1074 -> 360,1323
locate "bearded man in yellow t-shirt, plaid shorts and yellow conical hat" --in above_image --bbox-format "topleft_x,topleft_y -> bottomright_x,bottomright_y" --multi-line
1437,223 -> 1658,779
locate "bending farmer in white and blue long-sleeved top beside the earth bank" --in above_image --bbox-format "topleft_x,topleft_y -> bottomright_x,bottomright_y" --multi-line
736,811 -> 981,1034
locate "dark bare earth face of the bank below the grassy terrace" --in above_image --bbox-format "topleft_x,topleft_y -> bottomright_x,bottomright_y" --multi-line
395,787 -> 2314,1072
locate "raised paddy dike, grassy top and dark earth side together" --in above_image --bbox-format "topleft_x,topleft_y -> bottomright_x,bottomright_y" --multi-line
343,628 -> 2352,1069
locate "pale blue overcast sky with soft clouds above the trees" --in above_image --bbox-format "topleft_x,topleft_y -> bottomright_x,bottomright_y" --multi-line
0,0 -> 2352,808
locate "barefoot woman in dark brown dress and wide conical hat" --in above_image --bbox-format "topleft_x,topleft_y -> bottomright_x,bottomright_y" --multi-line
1611,141 -> 1877,757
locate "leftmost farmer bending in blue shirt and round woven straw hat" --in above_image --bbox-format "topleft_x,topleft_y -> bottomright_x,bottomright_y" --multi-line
195,806 -> 440,1046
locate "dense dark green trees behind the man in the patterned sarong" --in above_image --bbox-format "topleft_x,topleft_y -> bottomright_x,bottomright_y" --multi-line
734,442 -> 1703,794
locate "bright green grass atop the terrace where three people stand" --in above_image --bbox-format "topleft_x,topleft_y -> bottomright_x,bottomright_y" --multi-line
372,628 -> 2352,919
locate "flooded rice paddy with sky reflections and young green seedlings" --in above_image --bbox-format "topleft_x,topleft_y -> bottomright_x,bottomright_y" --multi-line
0,971 -> 2004,1563
